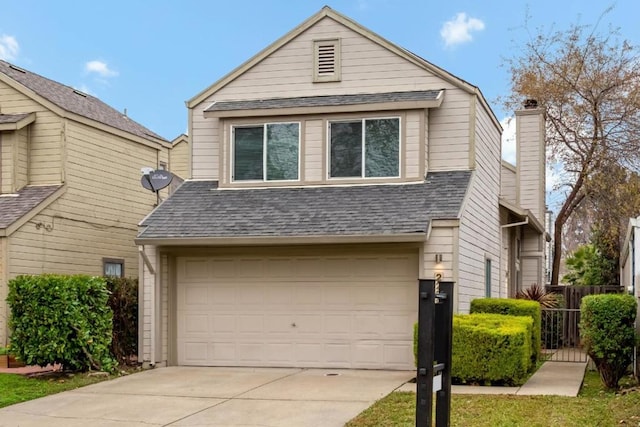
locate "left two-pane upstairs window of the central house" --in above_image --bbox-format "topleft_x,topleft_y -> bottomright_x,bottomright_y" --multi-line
232,123 -> 300,181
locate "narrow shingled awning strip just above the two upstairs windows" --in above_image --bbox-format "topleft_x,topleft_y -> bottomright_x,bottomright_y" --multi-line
204,90 -> 442,112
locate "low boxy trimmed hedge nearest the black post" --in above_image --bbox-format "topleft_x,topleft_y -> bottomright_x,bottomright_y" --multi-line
451,313 -> 533,385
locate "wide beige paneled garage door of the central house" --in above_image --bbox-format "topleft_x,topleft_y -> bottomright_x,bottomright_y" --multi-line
177,251 -> 418,369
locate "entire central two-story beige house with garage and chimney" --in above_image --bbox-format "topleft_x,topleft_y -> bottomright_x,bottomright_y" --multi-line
136,7 -> 544,369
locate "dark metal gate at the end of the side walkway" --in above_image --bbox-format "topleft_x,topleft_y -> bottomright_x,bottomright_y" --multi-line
541,308 -> 587,362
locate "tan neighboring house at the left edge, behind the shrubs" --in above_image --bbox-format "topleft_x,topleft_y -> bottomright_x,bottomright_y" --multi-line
0,61 -> 170,345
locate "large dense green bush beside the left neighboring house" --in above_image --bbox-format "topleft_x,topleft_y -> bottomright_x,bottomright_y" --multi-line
7,274 -> 115,371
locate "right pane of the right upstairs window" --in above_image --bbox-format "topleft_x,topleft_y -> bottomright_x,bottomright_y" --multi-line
365,119 -> 400,177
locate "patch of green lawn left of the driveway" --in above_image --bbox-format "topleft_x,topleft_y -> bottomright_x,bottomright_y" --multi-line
0,373 -> 108,408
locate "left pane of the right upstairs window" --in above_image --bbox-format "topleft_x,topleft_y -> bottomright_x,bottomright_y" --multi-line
331,121 -> 362,177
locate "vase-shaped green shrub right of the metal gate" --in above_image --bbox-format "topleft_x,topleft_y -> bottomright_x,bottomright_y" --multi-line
580,294 -> 636,389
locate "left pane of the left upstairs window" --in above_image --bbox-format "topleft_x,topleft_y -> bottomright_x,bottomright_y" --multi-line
233,126 -> 264,181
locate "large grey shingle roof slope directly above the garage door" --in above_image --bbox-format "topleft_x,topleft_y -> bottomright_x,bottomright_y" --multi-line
138,171 -> 471,244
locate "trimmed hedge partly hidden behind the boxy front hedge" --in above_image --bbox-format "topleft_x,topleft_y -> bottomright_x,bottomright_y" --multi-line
471,298 -> 542,366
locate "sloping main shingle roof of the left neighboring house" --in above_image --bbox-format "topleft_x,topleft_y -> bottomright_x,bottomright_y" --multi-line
0,60 -> 165,140
